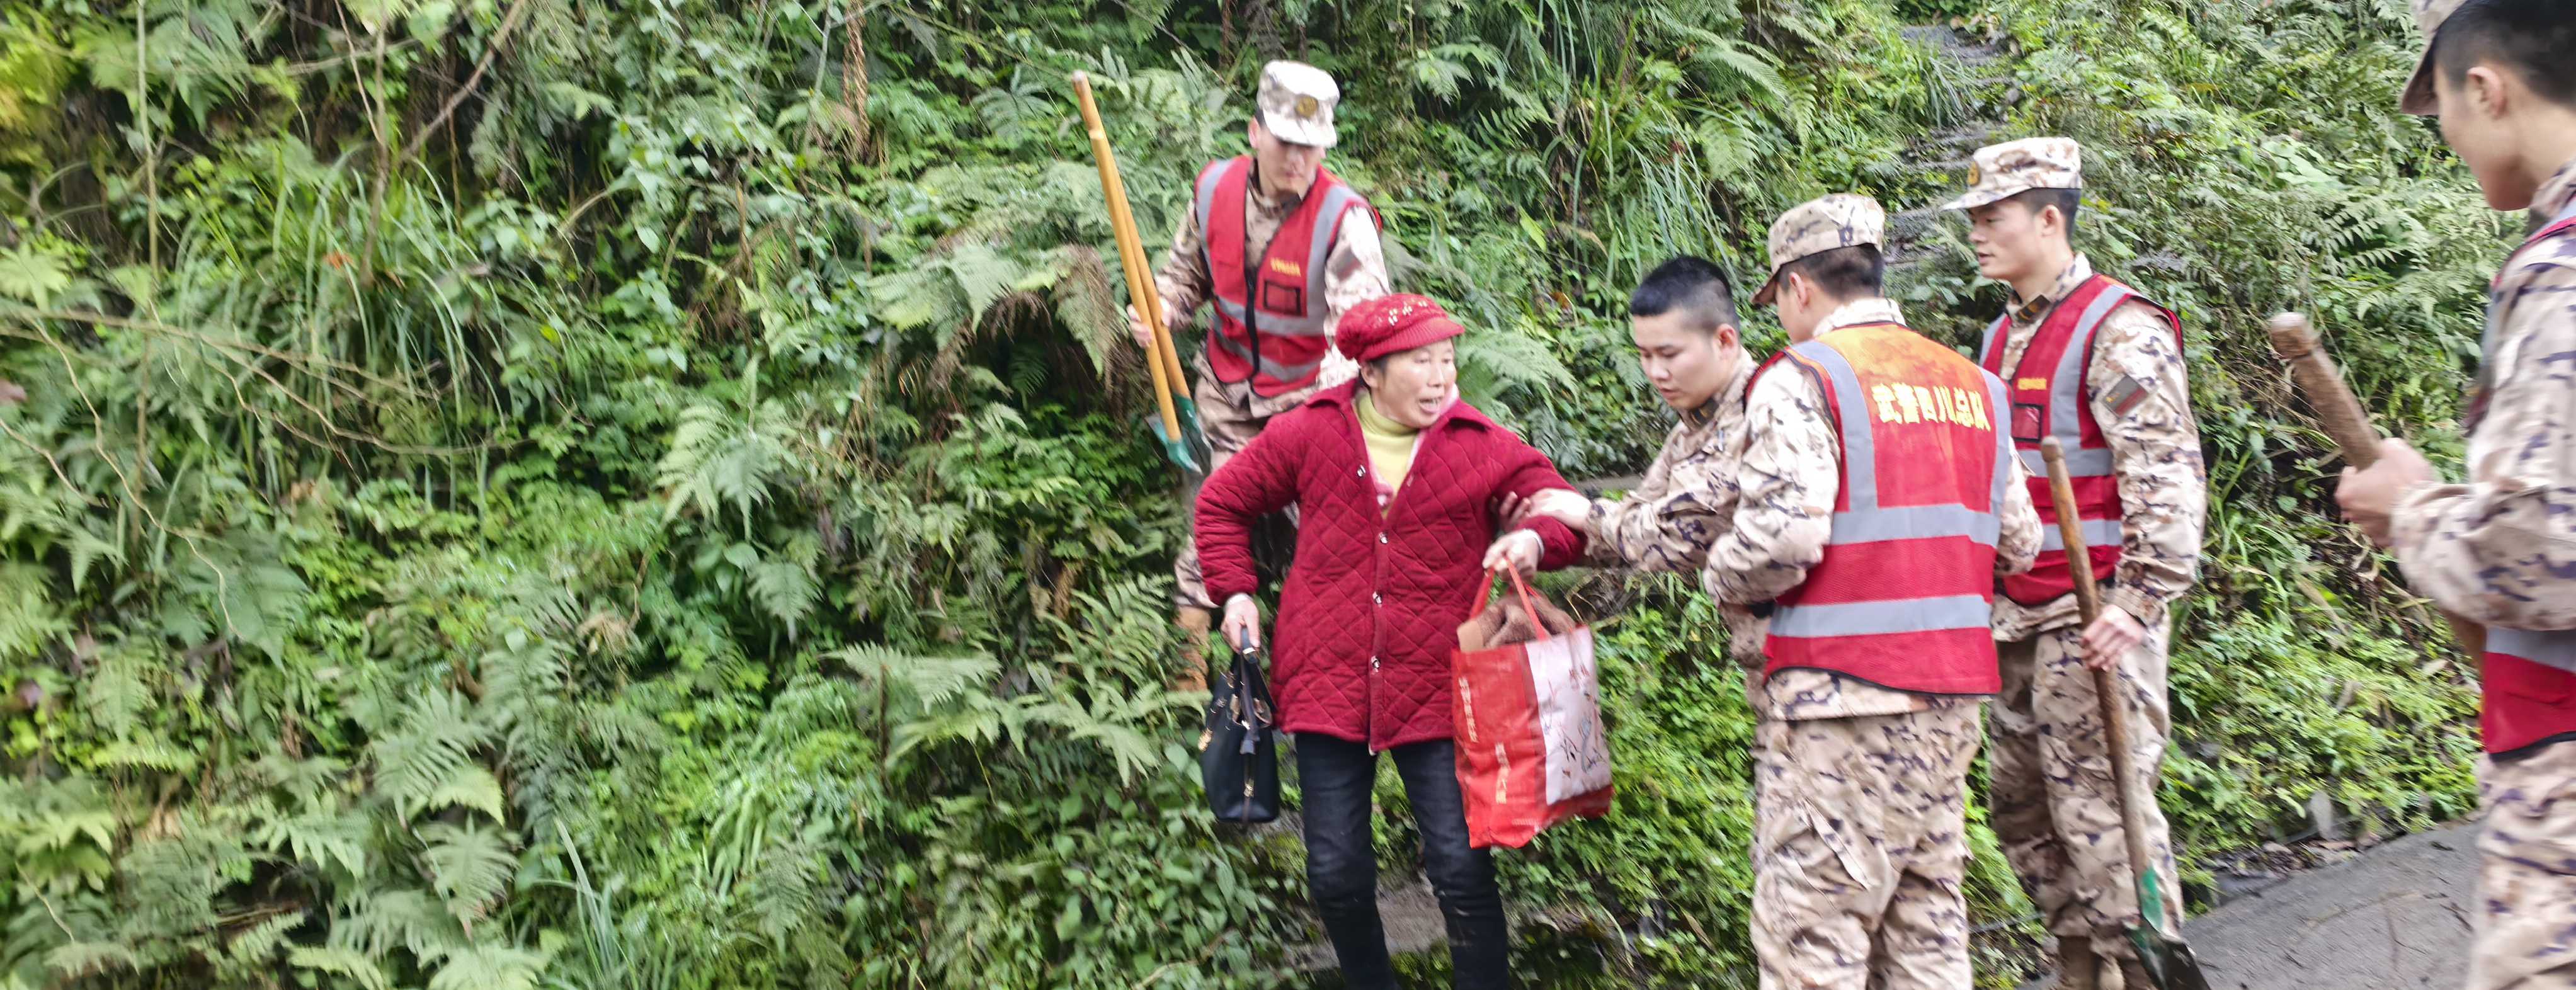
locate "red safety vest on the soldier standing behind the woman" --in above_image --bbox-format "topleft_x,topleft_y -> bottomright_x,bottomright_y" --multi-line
1198,157 -> 1376,397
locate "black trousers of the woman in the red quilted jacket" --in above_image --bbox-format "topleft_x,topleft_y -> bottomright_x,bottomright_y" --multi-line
1296,732 -> 1512,990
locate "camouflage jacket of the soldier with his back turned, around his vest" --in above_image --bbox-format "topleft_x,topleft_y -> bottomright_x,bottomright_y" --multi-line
1700,299 -> 2040,719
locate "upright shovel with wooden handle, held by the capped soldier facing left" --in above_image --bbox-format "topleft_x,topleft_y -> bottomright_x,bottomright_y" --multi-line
2040,436 -> 2210,990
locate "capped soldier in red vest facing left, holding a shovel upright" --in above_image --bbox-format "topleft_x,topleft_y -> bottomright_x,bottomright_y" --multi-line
1942,137 -> 2208,990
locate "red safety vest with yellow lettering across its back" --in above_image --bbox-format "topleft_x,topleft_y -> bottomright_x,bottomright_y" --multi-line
1762,322 -> 2012,693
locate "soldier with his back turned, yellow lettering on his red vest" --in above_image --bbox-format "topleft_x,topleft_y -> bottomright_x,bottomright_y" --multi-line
1700,196 -> 2040,990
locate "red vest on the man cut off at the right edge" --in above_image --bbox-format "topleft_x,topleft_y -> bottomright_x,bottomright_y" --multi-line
2468,207 -> 2576,753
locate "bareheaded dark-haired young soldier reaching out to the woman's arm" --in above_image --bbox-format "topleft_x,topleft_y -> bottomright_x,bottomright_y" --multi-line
1505,255 -> 1762,663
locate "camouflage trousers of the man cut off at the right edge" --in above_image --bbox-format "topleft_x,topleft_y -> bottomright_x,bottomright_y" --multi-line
2468,742 -> 2576,990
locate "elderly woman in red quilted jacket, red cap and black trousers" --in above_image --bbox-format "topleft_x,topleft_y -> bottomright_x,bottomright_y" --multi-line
1198,297 -> 1582,987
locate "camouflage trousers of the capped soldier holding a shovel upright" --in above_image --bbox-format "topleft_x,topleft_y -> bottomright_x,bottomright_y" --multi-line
1986,624 -> 2182,959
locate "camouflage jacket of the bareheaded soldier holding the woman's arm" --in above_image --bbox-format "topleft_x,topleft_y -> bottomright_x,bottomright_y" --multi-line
1584,356 -> 1770,660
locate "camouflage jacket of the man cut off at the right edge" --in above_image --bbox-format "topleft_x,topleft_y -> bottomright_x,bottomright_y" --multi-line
2391,162 -> 2576,629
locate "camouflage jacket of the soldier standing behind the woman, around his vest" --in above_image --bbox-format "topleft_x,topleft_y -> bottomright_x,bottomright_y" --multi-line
1154,165 -> 1394,418
